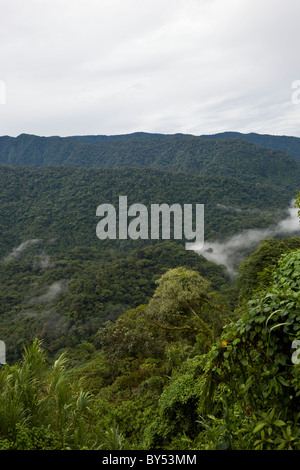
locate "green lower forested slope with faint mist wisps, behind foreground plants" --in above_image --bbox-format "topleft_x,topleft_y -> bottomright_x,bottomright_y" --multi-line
0,241 -> 230,366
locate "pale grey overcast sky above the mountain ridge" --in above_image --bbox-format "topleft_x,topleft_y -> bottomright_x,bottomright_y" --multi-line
0,0 -> 300,137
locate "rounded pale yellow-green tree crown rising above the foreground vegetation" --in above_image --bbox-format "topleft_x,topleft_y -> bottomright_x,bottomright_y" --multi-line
146,267 -> 226,348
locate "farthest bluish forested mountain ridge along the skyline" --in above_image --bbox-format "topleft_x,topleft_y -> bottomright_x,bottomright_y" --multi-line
0,134 -> 300,188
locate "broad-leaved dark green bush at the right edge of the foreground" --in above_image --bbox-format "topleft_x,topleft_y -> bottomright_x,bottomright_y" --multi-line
196,250 -> 300,449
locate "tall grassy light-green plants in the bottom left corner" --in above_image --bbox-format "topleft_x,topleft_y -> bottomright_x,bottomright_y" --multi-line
0,340 -> 94,450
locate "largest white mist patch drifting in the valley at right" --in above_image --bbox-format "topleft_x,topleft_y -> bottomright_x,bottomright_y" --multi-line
195,201 -> 300,277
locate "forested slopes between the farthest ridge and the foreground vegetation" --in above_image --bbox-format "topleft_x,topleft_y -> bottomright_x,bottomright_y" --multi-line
0,165 -> 295,364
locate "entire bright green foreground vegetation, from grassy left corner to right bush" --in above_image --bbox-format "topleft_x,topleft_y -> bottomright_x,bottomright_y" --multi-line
0,233 -> 300,450
